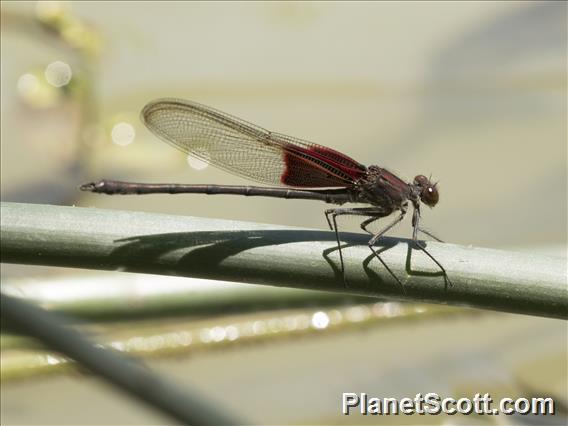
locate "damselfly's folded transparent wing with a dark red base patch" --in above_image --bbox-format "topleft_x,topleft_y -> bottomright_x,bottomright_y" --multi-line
142,99 -> 366,187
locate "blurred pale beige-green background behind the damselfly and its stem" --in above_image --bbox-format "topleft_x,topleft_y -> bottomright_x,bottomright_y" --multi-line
1,1 -> 568,424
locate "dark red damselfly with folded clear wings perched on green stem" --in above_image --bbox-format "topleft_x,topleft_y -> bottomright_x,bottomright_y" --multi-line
80,99 -> 449,288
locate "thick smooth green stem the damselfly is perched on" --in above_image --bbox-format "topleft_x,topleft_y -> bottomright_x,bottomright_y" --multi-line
1,203 -> 568,319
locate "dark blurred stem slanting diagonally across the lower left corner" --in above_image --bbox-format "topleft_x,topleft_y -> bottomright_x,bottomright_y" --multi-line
0,294 -> 241,425
